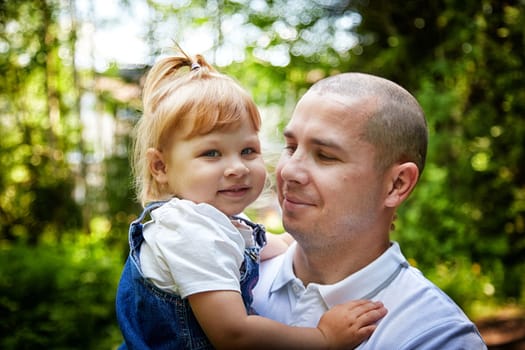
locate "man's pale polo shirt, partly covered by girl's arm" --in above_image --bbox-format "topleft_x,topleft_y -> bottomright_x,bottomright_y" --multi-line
253,242 -> 486,350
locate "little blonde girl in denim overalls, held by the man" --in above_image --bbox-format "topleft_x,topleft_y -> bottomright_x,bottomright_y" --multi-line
116,50 -> 386,349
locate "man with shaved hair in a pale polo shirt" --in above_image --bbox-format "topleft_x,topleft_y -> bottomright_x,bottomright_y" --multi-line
254,73 -> 486,350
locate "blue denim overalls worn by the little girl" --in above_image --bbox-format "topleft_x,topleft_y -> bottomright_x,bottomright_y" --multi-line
116,202 -> 266,350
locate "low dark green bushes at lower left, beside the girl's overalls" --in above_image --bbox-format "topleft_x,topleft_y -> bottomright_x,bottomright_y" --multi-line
0,233 -> 123,350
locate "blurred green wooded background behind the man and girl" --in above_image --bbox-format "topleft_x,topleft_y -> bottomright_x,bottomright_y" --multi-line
0,0 -> 525,349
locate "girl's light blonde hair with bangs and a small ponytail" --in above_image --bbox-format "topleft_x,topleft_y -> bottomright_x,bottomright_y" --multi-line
132,50 -> 261,205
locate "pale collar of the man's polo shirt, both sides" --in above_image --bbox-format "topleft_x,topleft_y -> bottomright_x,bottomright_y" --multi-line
270,242 -> 408,307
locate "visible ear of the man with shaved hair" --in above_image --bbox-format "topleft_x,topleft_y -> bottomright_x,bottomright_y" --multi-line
385,162 -> 419,208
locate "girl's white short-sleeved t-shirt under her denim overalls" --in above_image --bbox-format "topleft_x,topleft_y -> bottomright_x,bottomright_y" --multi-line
140,198 -> 254,298
